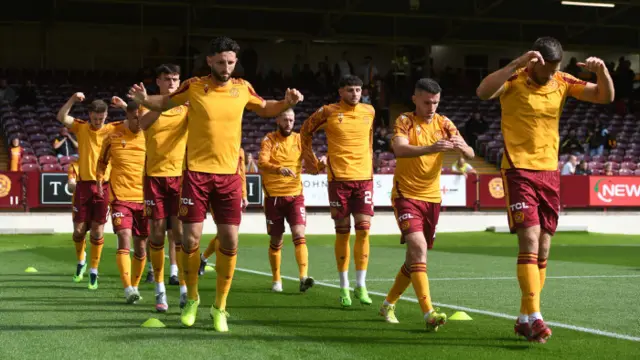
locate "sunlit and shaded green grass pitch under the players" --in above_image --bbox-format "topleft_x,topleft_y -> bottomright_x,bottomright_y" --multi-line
0,233 -> 640,360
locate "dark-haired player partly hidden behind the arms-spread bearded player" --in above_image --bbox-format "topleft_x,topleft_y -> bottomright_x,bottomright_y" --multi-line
140,64 -> 188,312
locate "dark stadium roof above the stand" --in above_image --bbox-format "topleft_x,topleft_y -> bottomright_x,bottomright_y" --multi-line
5,0 -> 640,51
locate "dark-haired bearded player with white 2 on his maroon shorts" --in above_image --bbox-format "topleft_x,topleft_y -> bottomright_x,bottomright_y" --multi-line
300,75 -> 375,307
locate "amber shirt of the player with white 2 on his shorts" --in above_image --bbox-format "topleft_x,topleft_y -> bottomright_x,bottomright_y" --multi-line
323,102 -> 375,181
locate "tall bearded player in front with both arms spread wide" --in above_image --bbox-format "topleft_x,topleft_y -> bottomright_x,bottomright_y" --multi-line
129,37 -> 303,332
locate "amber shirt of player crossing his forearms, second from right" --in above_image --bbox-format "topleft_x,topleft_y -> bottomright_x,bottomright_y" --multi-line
392,112 -> 458,203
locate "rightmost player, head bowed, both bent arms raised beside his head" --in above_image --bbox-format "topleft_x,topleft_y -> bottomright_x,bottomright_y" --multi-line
477,37 -> 614,343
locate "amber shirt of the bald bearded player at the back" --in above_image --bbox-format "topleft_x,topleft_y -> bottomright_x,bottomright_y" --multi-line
260,131 -> 302,196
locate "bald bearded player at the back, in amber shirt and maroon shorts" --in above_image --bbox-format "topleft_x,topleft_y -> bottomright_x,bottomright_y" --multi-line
258,109 -> 314,292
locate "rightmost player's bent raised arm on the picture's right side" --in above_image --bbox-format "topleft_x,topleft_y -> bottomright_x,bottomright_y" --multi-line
569,57 -> 615,104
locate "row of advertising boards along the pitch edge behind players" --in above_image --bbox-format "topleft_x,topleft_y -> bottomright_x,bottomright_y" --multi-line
0,172 -> 640,211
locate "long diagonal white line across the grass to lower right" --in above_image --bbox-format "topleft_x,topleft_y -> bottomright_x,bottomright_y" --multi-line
236,268 -> 640,342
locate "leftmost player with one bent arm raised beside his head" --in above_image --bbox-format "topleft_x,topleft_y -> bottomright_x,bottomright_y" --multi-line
57,92 -> 114,290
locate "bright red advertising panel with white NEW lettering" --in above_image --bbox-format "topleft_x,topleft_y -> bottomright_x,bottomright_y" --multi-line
589,176 -> 640,207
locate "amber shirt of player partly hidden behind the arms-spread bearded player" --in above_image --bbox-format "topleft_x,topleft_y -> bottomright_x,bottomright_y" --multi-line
145,105 -> 188,176
